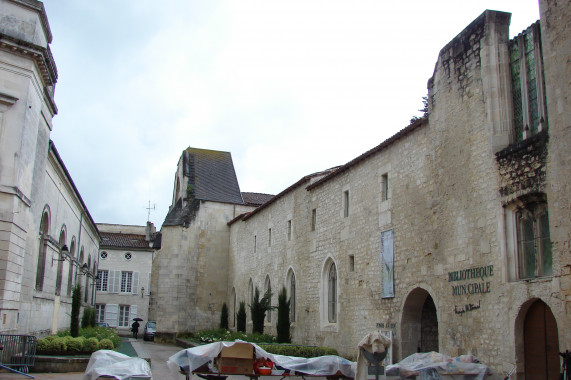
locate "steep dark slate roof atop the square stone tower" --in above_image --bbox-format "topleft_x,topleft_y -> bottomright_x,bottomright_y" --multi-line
183,147 -> 244,204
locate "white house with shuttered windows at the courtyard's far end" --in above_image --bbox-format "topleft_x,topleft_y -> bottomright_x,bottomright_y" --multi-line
95,222 -> 155,332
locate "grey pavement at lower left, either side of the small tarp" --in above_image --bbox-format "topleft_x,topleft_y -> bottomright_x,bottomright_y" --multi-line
0,338 -> 185,380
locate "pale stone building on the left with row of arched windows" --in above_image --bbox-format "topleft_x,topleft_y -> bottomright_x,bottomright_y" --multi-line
0,0 -> 99,335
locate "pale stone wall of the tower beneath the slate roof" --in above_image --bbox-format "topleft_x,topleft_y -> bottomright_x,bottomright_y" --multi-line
149,201 -> 252,340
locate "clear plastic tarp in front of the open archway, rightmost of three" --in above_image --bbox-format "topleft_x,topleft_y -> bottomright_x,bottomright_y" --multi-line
386,352 -> 488,380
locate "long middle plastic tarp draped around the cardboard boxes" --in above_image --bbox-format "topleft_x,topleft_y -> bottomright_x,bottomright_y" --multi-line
167,340 -> 357,378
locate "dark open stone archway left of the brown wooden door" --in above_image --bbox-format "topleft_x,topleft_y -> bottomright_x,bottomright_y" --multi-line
401,288 -> 439,358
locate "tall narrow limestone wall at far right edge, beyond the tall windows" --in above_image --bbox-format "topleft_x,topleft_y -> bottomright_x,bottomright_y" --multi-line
540,0 -> 571,351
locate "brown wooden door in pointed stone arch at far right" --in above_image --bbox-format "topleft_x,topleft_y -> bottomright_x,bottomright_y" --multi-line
523,300 -> 559,380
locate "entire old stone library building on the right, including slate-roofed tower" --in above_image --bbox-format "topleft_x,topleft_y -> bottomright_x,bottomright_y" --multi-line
150,0 -> 571,378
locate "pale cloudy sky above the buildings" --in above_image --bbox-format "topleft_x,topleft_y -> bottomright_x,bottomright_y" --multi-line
44,0 -> 539,228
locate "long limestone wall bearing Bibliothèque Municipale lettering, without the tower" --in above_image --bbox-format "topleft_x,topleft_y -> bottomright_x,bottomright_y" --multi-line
227,6 -> 571,378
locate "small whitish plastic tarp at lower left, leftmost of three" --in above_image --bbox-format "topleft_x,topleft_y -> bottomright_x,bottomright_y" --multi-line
82,350 -> 152,380
